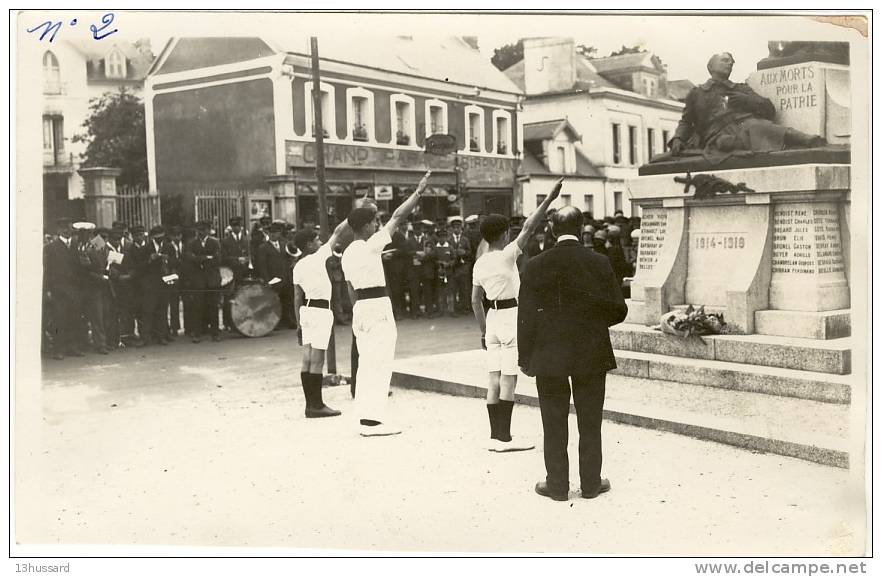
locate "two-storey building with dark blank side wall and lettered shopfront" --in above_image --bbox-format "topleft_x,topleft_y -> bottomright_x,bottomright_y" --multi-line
145,37 -> 521,226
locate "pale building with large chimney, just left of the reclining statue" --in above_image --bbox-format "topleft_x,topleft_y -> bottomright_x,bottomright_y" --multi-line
505,38 -> 683,218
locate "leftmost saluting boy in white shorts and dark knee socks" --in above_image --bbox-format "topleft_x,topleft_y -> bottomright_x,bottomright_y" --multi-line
292,221 -> 346,419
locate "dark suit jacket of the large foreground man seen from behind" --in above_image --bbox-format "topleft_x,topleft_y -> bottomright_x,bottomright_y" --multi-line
518,240 -> 628,376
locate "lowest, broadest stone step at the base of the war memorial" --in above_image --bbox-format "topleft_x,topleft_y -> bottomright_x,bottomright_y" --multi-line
392,351 -> 850,468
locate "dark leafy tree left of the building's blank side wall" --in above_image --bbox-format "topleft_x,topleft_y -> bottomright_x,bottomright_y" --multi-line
73,87 -> 147,185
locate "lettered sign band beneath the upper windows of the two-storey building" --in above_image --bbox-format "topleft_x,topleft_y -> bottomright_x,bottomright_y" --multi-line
285,140 -> 516,187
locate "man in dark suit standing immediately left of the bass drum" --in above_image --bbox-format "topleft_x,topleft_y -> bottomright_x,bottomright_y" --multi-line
182,221 -> 221,343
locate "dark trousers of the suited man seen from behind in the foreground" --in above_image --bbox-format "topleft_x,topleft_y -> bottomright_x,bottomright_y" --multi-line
536,373 -> 606,492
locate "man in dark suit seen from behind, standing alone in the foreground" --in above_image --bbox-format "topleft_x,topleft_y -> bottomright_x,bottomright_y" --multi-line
518,206 -> 628,501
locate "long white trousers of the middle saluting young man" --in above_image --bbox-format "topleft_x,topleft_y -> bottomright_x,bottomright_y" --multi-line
352,297 -> 398,423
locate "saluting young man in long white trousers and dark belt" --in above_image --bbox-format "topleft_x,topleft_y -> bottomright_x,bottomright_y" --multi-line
342,171 -> 431,437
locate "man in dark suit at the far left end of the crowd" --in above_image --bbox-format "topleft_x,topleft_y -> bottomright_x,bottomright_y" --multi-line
43,218 -> 85,360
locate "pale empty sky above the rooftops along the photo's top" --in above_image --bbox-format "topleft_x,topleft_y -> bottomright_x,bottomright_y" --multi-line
20,11 -> 866,83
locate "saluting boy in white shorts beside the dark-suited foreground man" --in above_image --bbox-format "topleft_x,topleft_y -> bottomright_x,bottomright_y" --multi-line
472,178 -> 563,453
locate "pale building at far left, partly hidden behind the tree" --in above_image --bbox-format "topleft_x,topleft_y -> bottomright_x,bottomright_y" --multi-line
40,40 -> 153,222
